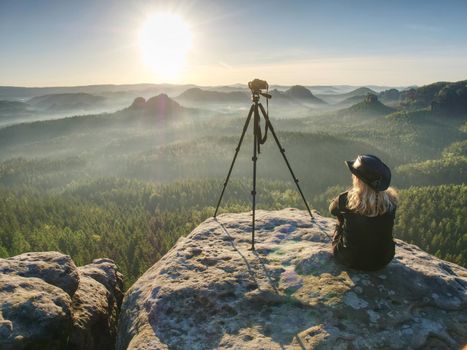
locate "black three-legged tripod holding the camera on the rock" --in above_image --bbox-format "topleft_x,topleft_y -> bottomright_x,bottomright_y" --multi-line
214,89 -> 313,251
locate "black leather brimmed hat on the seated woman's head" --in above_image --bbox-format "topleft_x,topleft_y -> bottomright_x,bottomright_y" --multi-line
345,154 -> 391,191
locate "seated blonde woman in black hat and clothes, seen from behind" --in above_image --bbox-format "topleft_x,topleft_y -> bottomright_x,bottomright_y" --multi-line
329,155 -> 397,271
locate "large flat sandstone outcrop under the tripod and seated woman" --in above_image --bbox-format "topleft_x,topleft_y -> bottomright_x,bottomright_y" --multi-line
117,209 -> 467,350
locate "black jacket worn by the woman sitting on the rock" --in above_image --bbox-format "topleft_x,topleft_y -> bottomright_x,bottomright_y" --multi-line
329,192 -> 396,271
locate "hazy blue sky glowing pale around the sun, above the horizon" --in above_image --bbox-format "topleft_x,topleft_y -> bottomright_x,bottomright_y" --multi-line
0,0 -> 467,86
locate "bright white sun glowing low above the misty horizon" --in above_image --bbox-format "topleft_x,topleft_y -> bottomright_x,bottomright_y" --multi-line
139,12 -> 192,80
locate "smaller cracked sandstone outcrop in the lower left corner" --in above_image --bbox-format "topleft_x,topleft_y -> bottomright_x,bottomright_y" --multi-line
0,252 -> 123,350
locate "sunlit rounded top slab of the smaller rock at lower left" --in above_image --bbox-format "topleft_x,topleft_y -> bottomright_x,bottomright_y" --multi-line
0,252 -> 79,296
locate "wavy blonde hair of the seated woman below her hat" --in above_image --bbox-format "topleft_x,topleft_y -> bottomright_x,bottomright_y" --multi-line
347,174 -> 399,216
